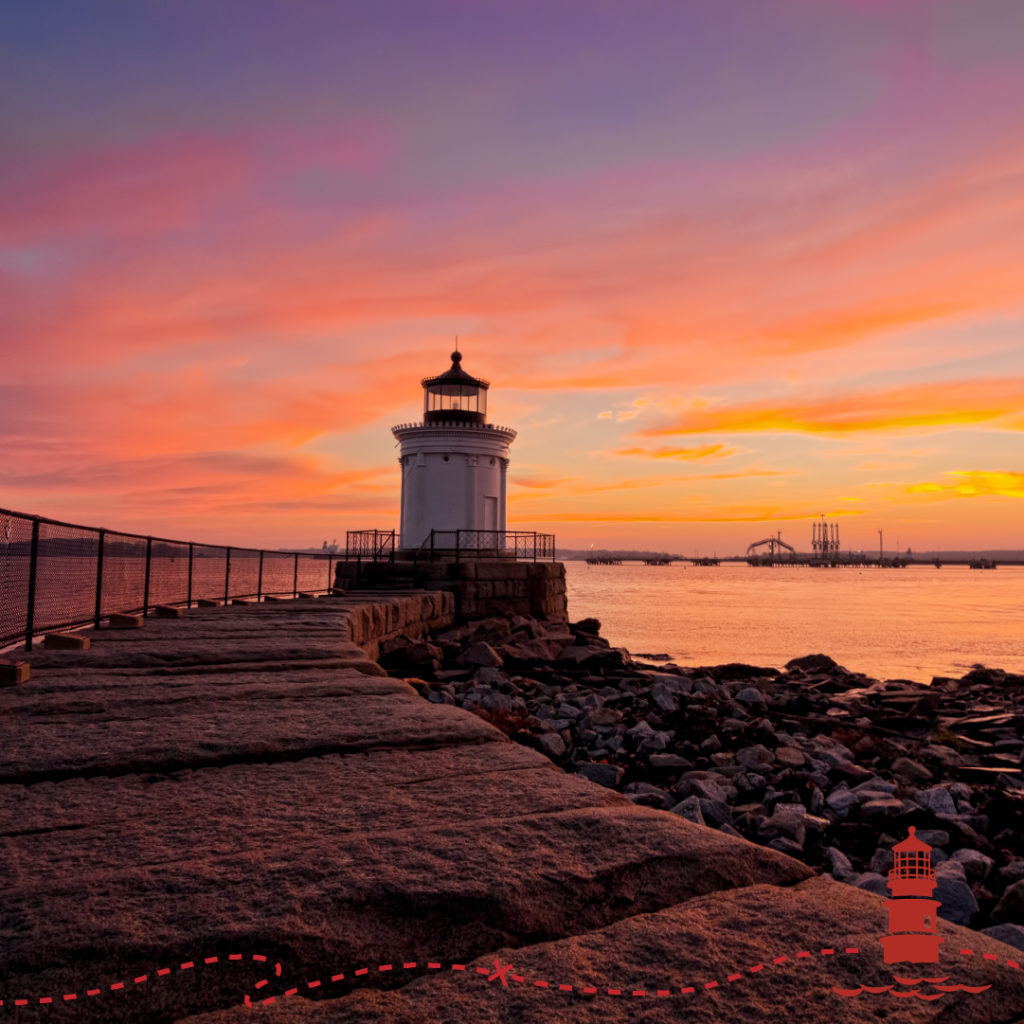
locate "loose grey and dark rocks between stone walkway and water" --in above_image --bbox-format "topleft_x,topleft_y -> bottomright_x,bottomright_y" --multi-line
380,616 -> 1024,948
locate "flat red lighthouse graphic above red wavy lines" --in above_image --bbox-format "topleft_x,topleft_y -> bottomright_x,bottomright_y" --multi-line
882,825 -> 942,964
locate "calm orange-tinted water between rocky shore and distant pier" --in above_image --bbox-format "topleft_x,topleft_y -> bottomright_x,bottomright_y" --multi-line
565,562 -> 1024,682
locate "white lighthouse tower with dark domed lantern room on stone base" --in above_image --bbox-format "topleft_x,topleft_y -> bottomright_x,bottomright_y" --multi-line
391,350 -> 516,550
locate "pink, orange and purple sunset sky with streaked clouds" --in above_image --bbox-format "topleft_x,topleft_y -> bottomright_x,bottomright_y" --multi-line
0,0 -> 1024,554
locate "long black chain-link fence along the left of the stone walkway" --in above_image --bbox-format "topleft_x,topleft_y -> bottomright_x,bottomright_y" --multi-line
0,509 -> 336,650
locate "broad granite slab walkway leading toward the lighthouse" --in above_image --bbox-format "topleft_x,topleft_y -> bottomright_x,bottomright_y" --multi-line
0,594 -> 1024,1024
